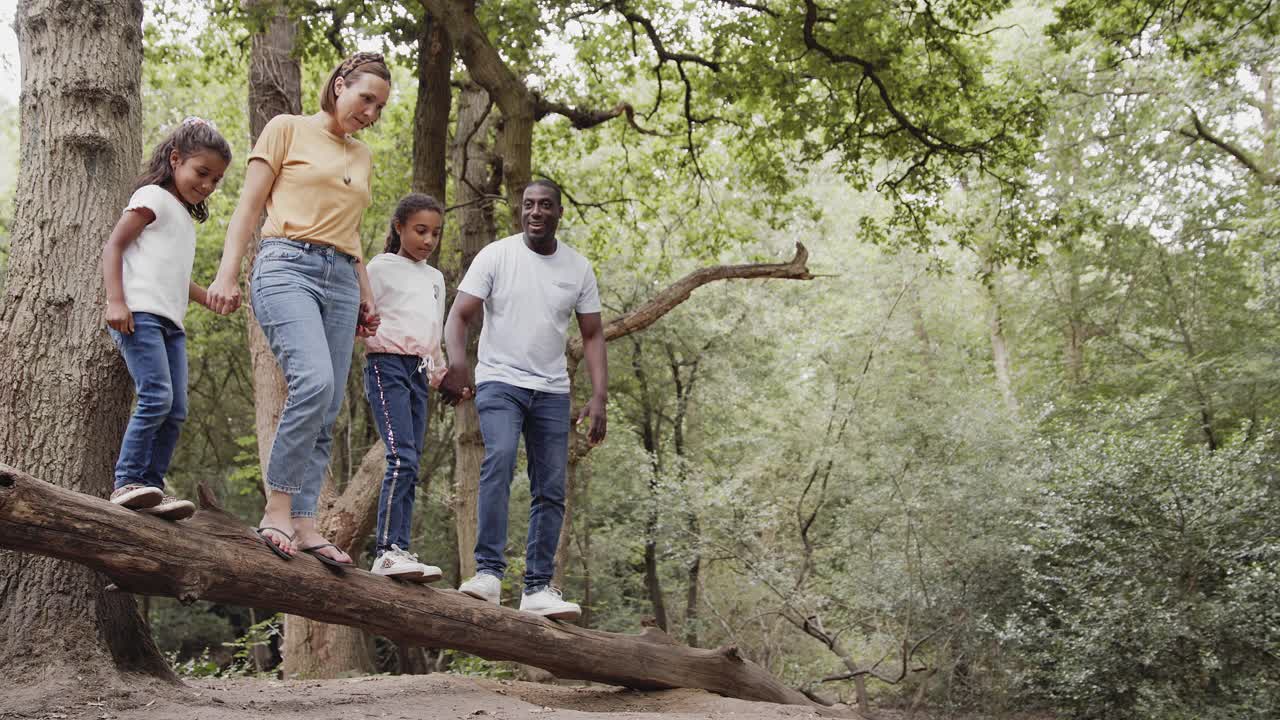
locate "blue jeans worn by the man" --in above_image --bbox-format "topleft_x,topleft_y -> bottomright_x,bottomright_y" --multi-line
476,382 -> 570,593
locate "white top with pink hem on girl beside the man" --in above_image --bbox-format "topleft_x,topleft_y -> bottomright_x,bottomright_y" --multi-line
365,252 -> 448,378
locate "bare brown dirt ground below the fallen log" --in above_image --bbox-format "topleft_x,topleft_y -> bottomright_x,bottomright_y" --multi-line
0,674 -> 860,720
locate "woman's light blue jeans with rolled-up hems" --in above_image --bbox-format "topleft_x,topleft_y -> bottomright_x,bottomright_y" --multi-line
251,237 -> 360,518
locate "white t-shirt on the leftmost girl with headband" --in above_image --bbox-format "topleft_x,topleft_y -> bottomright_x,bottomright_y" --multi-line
123,184 -> 196,328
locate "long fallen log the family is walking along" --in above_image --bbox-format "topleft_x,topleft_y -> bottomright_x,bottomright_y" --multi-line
0,464 -> 829,714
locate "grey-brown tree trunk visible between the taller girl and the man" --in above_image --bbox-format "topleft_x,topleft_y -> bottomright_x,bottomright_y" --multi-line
453,85 -> 498,579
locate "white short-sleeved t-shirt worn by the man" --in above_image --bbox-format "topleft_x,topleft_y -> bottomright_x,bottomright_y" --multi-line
458,233 -> 600,393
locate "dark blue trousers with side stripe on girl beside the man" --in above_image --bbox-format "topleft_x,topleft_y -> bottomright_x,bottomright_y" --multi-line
365,352 -> 430,555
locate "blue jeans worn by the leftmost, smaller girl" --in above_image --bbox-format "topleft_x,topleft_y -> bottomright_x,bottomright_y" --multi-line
111,313 -> 187,489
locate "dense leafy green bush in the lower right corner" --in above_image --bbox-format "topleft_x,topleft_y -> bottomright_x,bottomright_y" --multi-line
1005,405 -> 1280,719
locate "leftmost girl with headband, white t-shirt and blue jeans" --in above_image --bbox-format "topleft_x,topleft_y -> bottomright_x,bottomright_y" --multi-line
102,118 -> 232,520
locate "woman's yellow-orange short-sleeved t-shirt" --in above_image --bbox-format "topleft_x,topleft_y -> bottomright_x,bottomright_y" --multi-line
248,115 -> 374,260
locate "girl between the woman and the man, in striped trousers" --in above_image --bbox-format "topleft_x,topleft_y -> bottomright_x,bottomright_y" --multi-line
365,192 -> 460,583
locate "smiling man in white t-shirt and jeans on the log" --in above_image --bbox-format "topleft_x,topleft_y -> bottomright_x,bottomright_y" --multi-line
440,179 -> 608,620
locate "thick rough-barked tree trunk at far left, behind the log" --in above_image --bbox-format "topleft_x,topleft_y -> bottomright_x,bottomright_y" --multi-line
0,0 -> 173,684
